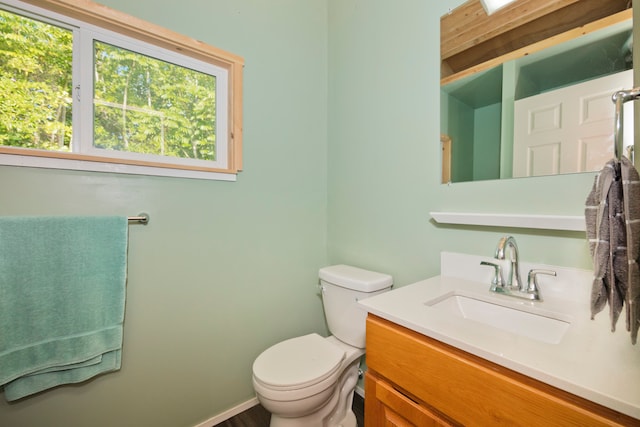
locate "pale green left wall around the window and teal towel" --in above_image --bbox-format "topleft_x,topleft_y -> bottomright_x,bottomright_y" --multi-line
0,0 -> 327,427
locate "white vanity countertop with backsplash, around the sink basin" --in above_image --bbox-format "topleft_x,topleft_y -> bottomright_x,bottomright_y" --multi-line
360,254 -> 640,419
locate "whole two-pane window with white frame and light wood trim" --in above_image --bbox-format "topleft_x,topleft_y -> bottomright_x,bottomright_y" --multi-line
0,0 -> 243,180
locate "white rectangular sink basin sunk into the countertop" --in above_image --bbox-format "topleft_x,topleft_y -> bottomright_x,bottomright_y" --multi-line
425,292 -> 571,344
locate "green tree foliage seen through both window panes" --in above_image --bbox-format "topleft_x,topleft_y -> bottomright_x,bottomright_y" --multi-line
0,11 -> 216,160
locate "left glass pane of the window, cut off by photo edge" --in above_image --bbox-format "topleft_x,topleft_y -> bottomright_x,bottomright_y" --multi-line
0,11 -> 73,151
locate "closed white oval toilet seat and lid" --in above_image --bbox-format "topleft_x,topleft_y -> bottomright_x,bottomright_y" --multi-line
253,334 -> 345,391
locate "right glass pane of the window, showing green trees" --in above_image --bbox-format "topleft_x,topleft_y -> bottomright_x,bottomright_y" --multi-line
94,41 -> 216,160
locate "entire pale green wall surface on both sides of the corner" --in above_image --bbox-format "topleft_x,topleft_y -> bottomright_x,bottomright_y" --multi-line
0,0 -> 604,427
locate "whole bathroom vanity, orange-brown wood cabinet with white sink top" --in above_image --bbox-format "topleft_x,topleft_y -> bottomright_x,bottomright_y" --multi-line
360,254 -> 640,426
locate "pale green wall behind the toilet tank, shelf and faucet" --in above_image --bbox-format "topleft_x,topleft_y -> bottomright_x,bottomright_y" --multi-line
327,0 -> 593,286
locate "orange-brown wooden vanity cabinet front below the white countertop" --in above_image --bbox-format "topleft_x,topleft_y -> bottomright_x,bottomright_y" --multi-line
365,314 -> 640,427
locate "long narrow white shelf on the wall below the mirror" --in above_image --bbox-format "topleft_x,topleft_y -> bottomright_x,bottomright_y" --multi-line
430,212 -> 586,231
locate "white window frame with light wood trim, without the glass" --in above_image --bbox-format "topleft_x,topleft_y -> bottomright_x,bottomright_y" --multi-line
0,0 -> 243,181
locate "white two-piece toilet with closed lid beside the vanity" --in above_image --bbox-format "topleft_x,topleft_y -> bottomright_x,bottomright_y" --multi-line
253,265 -> 393,427
